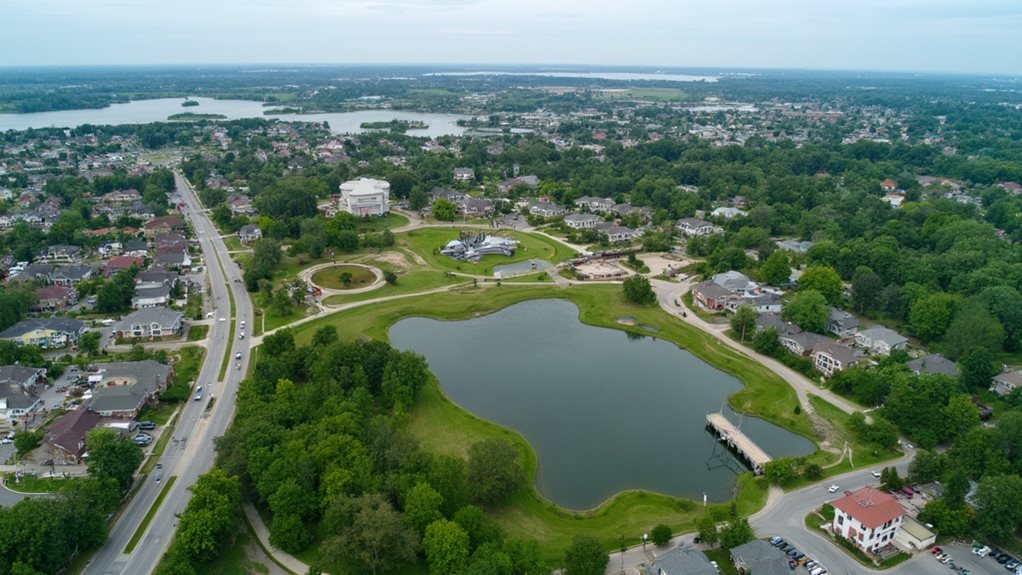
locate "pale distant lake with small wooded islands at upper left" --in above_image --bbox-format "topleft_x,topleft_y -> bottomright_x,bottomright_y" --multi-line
0,98 -> 468,138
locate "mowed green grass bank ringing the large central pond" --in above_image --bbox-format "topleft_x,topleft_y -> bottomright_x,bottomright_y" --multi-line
295,285 -> 812,561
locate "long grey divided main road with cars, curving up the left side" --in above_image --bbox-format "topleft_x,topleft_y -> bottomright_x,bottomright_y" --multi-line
85,174 -> 252,575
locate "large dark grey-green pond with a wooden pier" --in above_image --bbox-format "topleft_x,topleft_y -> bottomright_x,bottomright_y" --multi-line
389,299 -> 815,510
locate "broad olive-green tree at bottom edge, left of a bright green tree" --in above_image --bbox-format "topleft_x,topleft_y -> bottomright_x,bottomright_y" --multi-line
323,493 -> 419,574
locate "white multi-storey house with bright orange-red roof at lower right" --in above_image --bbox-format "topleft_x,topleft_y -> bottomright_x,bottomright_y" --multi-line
831,487 -> 905,553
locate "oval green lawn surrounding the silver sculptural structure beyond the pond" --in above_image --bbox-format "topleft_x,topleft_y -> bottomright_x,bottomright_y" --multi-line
398,227 -> 574,276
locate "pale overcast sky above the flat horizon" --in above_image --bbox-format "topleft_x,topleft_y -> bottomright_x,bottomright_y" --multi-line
7,0 -> 1022,75
